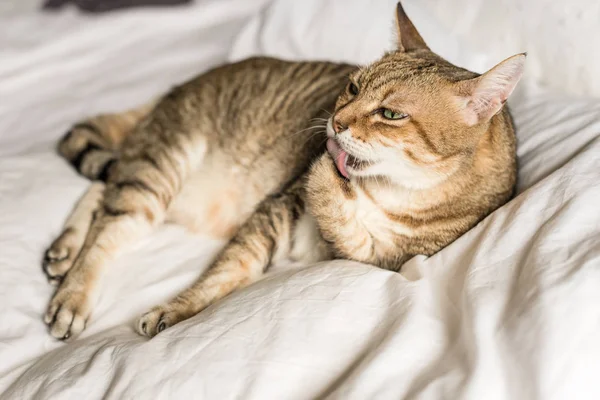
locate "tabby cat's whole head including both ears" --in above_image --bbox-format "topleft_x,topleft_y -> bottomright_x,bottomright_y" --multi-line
327,3 -> 525,189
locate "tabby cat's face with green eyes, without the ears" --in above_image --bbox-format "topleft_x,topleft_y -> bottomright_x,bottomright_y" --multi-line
327,51 -> 474,187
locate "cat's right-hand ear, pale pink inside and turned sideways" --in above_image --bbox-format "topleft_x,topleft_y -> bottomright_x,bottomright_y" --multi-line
458,53 -> 527,126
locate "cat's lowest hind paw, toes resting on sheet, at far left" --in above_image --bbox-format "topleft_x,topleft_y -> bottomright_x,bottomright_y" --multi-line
44,280 -> 91,340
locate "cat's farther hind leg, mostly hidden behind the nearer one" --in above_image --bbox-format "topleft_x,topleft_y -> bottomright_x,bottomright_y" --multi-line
43,181 -> 105,285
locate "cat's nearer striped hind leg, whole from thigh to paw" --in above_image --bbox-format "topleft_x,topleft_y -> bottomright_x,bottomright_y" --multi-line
44,131 -> 207,339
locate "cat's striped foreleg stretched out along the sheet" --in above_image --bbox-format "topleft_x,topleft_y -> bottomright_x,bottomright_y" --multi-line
136,180 -> 304,337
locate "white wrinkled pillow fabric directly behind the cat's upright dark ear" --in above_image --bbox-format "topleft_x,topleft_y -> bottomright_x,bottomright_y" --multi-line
229,0 -> 492,72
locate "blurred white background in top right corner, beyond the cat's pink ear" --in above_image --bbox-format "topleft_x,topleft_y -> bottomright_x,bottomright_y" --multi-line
420,0 -> 600,97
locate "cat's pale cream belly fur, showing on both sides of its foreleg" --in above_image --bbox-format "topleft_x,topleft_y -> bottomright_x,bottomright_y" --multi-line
167,145 -> 330,264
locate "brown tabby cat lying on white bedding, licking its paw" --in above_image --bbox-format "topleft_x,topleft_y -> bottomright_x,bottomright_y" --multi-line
44,4 -> 525,340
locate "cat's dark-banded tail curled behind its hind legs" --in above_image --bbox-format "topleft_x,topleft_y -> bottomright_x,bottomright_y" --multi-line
58,101 -> 157,181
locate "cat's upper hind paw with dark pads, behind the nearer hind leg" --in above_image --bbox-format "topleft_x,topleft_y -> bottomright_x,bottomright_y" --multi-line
42,228 -> 81,286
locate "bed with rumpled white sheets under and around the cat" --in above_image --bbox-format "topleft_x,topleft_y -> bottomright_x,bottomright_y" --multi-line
0,0 -> 600,399
